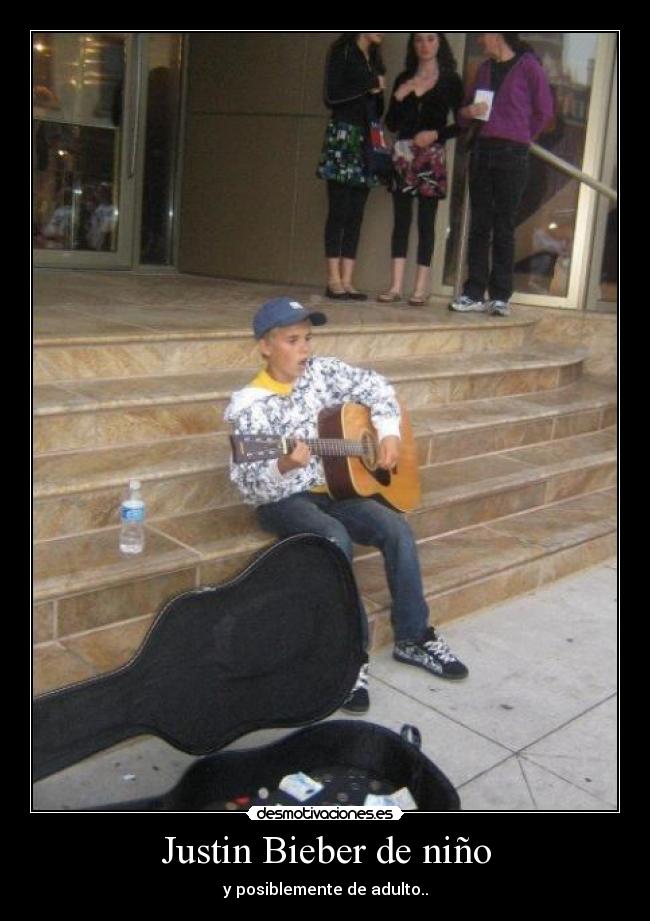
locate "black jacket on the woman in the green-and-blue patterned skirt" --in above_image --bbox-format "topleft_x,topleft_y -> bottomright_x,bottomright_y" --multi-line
325,43 -> 384,127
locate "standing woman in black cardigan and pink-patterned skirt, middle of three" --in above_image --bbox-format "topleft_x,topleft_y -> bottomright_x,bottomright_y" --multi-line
378,32 -> 463,307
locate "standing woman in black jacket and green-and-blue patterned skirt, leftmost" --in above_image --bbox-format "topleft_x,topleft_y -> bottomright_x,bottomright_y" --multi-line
317,32 -> 385,301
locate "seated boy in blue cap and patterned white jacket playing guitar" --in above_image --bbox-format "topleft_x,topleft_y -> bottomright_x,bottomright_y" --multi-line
225,297 -> 468,713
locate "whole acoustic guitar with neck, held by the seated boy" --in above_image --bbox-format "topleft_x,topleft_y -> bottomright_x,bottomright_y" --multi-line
230,403 -> 420,512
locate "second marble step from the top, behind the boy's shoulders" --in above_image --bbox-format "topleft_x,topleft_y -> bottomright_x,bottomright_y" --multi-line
34,345 -> 586,455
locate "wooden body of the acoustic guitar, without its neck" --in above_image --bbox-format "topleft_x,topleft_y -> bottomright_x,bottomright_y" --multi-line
318,403 -> 420,512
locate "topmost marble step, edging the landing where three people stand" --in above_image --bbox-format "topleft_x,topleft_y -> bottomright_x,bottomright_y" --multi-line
34,308 -> 536,384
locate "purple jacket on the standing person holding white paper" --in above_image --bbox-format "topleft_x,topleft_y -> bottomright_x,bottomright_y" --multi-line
461,52 -> 555,144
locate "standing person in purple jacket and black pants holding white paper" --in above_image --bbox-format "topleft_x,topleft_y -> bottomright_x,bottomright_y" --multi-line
449,32 -> 554,316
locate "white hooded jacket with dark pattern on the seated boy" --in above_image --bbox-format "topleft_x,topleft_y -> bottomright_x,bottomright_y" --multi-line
224,358 -> 400,505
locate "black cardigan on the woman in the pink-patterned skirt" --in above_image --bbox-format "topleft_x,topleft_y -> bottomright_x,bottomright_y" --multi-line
386,71 -> 463,144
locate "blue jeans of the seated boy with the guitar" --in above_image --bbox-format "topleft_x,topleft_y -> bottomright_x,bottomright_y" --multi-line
257,492 -> 429,641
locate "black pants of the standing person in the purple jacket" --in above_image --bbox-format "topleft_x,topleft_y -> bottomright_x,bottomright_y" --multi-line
464,142 -> 528,301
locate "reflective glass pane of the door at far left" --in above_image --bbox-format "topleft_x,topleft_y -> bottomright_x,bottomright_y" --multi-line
33,32 -> 124,252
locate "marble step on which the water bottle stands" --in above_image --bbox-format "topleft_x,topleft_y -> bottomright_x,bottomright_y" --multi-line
33,428 -> 617,619
